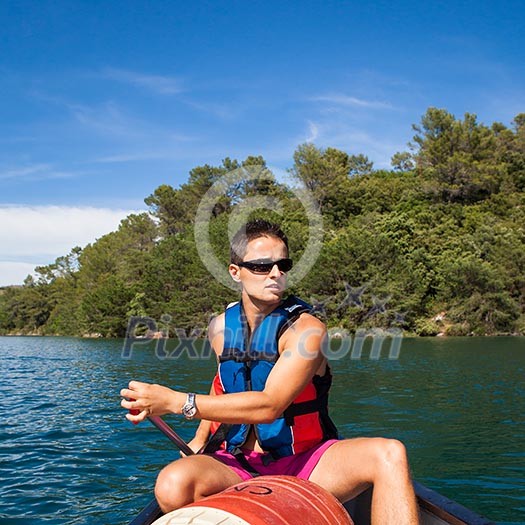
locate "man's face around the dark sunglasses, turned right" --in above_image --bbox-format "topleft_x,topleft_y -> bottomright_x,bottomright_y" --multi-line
229,237 -> 288,303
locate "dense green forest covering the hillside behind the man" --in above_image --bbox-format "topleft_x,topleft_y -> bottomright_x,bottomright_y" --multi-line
0,108 -> 525,337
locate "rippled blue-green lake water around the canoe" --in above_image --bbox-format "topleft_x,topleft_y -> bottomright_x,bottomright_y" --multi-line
0,337 -> 525,525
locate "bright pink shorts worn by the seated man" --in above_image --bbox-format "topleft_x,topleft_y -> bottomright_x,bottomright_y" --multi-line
211,439 -> 338,481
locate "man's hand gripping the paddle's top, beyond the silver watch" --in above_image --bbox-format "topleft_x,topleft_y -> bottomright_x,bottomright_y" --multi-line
120,381 -> 186,423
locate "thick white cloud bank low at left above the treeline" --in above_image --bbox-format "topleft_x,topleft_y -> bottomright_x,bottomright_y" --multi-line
0,206 -> 142,285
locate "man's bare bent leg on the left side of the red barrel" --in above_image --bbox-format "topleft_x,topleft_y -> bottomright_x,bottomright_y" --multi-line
155,455 -> 242,512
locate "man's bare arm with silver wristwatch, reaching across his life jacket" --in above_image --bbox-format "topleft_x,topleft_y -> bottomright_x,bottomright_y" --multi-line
121,314 -> 326,424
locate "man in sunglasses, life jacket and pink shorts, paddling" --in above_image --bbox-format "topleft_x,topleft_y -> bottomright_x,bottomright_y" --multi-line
121,220 -> 418,525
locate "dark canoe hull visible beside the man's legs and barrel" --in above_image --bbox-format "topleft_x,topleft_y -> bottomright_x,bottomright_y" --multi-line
129,482 -> 495,525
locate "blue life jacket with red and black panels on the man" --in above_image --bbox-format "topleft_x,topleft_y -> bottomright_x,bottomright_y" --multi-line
212,296 -> 337,458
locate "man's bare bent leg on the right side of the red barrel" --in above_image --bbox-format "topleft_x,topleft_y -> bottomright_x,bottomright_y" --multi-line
309,438 -> 419,525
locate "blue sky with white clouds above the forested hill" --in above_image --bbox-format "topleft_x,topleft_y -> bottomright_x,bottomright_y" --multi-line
0,0 -> 525,286
